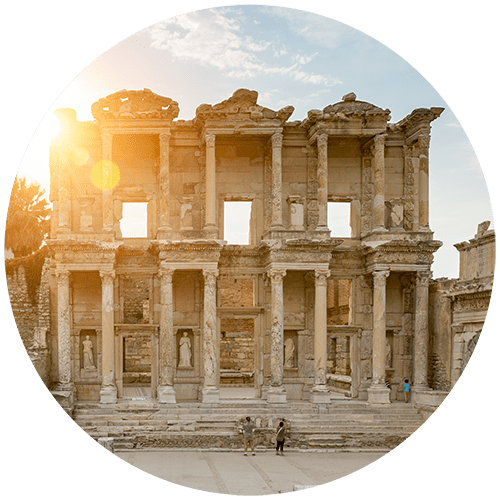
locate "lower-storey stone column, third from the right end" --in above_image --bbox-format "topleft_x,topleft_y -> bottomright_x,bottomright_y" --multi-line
311,270 -> 330,403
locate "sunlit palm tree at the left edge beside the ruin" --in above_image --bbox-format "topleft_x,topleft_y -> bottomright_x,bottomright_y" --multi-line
4,177 -> 51,257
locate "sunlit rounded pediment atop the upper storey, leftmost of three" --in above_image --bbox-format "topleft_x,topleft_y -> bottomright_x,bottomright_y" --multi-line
91,89 -> 179,121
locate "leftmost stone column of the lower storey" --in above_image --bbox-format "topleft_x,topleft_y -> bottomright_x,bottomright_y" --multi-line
56,269 -> 73,391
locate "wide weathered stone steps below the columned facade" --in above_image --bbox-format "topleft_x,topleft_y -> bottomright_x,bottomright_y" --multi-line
73,399 -> 424,451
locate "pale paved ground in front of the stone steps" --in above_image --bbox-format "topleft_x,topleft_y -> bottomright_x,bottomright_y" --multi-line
116,451 -> 384,496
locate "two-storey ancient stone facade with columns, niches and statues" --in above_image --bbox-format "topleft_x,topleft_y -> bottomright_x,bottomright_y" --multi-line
17,89 -> 454,403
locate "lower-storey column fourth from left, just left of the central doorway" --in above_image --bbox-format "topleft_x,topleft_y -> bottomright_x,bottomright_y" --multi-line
202,269 -> 220,403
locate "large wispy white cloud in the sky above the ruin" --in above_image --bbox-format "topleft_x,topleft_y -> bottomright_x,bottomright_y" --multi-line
147,7 -> 341,86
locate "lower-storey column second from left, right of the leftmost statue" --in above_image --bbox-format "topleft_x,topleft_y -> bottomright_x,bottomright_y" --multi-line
99,271 -> 117,403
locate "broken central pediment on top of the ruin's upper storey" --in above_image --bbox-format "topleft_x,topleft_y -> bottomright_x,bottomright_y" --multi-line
195,89 -> 294,129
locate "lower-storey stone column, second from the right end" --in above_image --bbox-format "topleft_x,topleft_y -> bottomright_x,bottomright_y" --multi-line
368,270 -> 391,403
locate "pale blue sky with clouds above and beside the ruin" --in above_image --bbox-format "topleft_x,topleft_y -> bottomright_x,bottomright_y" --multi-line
14,5 -> 493,278
